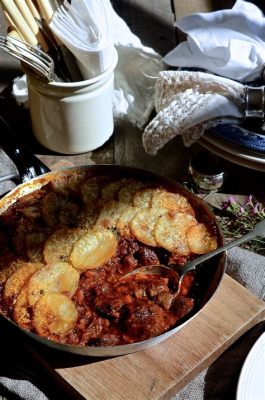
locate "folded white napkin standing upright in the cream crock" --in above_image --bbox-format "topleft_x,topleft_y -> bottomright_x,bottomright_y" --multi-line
50,0 -> 115,79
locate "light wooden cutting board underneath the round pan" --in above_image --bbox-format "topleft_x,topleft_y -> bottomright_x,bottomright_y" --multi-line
27,275 -> 265,400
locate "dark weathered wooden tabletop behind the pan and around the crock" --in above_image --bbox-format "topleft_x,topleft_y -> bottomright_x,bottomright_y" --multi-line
0,0 -> 264,197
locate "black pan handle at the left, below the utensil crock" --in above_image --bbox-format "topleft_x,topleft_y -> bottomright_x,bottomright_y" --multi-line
0,116 -> 50,182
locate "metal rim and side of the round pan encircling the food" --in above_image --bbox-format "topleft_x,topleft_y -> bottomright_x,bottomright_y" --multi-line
0,164 -> 227,357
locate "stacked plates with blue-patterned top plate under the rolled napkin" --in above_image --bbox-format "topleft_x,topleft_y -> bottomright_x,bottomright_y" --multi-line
199,124 -> 265,172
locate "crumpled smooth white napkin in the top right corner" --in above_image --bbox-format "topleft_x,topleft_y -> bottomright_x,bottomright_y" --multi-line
164,0 -> 265,81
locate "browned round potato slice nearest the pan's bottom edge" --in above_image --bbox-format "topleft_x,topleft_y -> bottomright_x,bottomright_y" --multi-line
32,293 -> 78,337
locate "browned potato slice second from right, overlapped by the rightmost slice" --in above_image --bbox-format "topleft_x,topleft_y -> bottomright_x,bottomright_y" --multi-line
154,212 -> 197,255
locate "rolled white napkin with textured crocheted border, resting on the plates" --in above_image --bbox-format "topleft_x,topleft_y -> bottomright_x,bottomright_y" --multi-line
143,71 -> 245,155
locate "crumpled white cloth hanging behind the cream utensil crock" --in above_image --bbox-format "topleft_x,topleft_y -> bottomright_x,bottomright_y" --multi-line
105,0 -> 165,128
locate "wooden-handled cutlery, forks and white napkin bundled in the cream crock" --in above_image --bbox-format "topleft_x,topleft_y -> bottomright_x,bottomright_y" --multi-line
0,0 -> 116,82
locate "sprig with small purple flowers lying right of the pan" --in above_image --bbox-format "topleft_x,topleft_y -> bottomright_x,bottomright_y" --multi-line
218,195 -> 265,255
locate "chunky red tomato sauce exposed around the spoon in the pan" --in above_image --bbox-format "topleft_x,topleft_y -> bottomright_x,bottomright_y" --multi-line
64,238 -> 194,346
